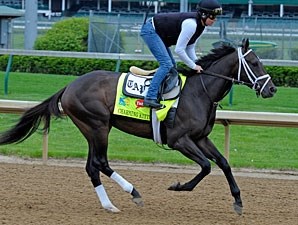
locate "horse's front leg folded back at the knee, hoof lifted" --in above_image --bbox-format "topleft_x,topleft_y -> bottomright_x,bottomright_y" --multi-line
168,135 -> 211,191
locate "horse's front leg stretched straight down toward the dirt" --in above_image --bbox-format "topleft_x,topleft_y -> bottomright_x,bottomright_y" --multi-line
197,137 -> 243,215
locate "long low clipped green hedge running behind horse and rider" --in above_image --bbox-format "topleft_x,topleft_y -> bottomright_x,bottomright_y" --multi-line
0,55 -> 298,87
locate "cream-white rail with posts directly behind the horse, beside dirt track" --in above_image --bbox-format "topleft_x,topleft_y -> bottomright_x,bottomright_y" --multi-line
0,100 -> 298,163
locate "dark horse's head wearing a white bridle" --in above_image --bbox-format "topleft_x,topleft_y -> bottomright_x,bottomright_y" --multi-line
237,39 -> 277,98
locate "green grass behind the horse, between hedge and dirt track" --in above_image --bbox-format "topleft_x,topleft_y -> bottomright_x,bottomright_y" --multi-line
0,72 -> 298,169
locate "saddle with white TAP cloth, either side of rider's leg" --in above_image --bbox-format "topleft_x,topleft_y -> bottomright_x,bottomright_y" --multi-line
123,66 -> 182,100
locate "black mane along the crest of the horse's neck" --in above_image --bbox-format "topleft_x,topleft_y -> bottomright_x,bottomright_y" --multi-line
196,44 -> 236,70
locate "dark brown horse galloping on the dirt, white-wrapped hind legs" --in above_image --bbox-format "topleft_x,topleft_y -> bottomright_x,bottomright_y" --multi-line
0,39 -> 276,214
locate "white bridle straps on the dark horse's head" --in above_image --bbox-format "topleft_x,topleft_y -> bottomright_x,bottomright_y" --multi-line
238,47 -> 271,94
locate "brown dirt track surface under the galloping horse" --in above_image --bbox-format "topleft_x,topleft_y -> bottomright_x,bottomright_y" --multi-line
0,157 -> 298,225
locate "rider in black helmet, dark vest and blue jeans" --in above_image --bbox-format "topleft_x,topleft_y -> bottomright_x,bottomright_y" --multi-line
140,0 -> 222,108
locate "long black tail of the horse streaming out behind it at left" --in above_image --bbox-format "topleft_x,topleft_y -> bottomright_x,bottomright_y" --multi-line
0,87 -> 66,145
